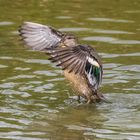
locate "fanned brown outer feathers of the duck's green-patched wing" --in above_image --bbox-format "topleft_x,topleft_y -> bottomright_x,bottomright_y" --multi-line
49,45 -> 88,74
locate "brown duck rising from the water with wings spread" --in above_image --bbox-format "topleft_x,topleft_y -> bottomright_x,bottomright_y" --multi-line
19,22 -> 105,104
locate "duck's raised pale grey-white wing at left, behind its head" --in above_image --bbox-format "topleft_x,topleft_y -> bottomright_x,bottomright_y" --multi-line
19,22 -> 64,51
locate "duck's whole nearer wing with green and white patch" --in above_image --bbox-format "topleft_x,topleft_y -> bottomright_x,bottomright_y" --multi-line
49,45 -> 102,90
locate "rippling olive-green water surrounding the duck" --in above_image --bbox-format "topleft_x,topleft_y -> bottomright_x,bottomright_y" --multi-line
0,0 -> 140,140
